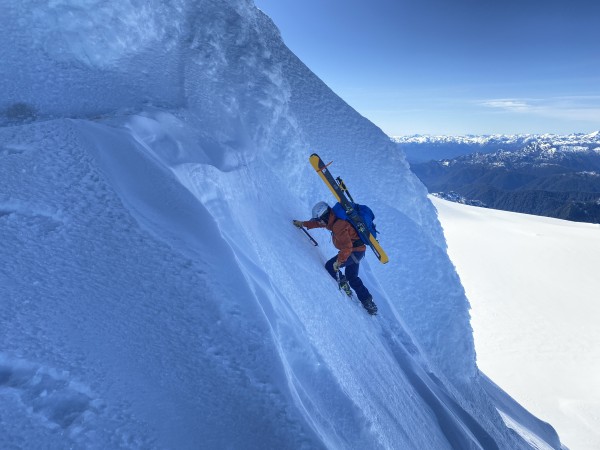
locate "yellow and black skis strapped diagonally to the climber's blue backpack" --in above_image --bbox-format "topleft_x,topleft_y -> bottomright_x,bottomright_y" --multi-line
310,153 -> 389,264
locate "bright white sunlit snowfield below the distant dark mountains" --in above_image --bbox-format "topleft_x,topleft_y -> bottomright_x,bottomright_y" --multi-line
432,198 -> 600,450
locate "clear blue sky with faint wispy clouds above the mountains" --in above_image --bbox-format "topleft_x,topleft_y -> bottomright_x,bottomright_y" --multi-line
255,0 -> 600,135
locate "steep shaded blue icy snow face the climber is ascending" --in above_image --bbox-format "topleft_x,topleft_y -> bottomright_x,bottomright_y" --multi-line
0,0 -> 560,449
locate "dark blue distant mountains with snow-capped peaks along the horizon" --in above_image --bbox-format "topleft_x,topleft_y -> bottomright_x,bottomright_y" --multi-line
396,132 -> 600,223
